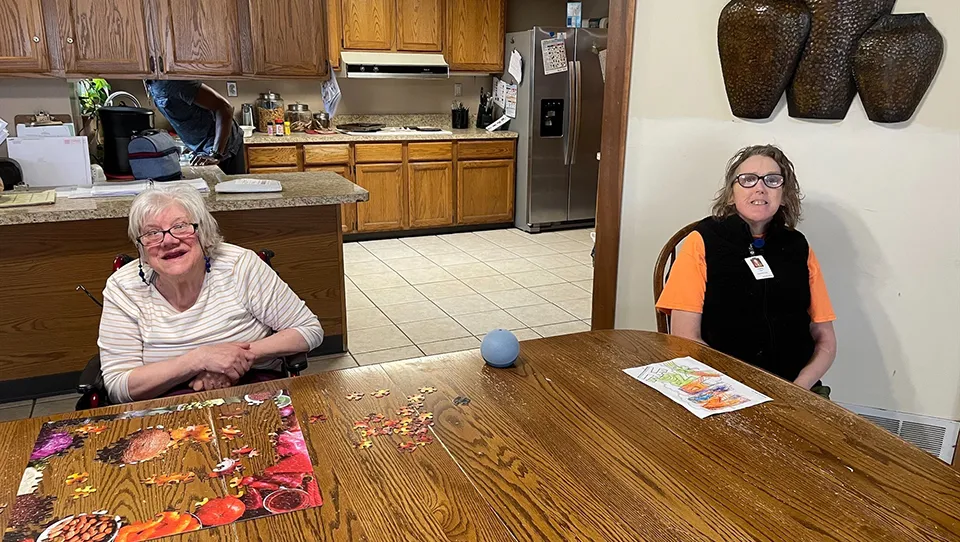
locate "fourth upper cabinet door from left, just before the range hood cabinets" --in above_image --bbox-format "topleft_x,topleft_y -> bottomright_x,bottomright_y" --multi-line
249,0 -> 327,77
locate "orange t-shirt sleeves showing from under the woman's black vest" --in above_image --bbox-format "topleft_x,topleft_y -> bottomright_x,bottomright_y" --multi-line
657,231 -> 837,324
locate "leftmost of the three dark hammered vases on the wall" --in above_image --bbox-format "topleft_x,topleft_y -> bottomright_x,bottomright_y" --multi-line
717,0 -> 810,119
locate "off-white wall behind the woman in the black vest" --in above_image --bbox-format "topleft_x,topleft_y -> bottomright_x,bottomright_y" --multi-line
617,0 -> 960,419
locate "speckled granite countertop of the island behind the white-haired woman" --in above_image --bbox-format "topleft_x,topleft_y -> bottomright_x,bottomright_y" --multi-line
0,166 -> 370,226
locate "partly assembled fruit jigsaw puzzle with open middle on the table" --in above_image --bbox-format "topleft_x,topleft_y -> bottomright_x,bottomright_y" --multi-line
3,390 -> 323,542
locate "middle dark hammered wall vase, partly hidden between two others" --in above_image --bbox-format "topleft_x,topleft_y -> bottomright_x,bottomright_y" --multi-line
787,0 -> 896,120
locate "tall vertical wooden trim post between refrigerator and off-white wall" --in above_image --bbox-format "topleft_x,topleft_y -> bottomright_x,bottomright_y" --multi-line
592,0 -> 637,329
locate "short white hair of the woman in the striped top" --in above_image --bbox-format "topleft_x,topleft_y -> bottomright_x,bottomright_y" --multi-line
127,182 -> 223,256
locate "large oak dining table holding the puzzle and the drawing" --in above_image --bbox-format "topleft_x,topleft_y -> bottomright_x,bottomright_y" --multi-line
0,330 -> 960,542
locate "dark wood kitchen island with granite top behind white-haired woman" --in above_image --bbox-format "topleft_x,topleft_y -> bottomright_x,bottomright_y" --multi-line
0,166 -> 369,400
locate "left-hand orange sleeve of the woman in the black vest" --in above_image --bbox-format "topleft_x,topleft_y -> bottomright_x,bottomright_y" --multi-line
657,231 -> 707,314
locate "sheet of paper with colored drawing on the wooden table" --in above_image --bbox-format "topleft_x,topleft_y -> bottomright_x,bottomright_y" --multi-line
624,357 -> 771,418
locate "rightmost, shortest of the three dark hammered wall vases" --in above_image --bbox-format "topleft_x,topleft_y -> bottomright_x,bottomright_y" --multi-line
853,13 -> 943,123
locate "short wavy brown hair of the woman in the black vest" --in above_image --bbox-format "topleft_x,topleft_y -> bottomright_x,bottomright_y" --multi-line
713,145 -> 803,229
